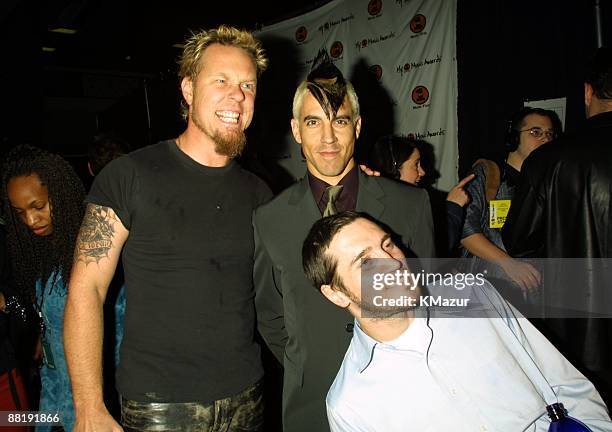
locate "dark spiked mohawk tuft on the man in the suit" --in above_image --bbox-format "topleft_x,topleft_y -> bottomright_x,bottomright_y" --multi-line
306,49 -> 346,118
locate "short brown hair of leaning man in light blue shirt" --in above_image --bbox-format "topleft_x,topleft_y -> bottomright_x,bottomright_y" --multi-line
302,211 -> 365,290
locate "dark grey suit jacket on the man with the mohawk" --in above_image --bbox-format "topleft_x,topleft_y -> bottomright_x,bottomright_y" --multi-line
253,173 -> 434,432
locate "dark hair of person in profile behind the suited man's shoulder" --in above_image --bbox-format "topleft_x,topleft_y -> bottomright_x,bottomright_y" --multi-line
369,135 -> 418,179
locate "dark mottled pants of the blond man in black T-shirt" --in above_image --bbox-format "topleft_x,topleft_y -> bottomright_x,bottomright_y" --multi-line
121,381 -> 264,432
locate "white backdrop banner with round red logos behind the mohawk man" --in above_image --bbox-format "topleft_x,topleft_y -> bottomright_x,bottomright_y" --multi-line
257,0 -> 458,190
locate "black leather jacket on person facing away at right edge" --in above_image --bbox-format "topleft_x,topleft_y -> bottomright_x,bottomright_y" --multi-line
503,112 -> 612,383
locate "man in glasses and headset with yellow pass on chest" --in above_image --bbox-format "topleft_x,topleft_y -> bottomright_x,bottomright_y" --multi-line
461,107 -> 561,304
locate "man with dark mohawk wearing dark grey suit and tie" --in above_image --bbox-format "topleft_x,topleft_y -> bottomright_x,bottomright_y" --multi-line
253,52 -> 434,432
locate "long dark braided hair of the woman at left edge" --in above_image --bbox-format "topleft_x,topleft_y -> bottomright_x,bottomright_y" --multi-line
0,145 -> 85,296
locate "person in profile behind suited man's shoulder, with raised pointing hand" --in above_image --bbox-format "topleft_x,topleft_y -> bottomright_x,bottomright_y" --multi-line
369,135 -> 474,256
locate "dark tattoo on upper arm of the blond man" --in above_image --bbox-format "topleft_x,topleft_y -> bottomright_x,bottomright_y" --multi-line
74,204 -> 117,265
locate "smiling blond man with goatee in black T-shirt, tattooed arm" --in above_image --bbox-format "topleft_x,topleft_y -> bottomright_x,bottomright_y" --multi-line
65,26 -> 270,431
